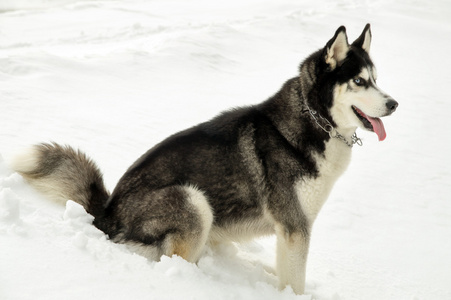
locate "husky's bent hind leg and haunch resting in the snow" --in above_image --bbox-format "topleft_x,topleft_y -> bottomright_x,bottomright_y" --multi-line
118,186 -> 213,262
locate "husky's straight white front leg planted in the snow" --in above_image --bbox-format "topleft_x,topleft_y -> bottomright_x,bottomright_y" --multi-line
276,226 -> 310,295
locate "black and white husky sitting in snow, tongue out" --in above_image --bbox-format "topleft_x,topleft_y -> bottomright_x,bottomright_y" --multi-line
14,24 -> 398,294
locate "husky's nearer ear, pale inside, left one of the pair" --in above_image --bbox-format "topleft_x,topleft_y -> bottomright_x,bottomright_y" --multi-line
325,26 -> 349,70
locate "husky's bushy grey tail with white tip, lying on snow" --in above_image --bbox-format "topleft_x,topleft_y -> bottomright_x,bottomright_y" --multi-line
12,143 -> 109,217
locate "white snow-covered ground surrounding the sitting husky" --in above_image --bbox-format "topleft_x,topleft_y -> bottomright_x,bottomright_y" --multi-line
0,0 -> 451,300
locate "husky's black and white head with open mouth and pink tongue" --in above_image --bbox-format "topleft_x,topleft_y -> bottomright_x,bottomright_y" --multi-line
301,24 -> 398,141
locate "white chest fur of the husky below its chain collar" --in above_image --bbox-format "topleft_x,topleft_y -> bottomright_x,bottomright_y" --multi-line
294,139 -> 351,224
